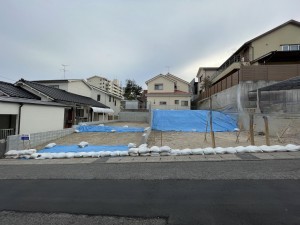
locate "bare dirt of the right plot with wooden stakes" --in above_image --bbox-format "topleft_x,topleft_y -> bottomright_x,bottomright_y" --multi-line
148,131 -> 300,149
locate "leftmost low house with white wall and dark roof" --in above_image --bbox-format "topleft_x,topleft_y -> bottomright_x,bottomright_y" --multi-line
0,81 -> 66,139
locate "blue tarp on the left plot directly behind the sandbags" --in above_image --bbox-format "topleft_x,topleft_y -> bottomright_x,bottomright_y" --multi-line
38,145 -> 129,153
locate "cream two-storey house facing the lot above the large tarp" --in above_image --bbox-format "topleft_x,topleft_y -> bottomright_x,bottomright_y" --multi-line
146,73 -> 192,109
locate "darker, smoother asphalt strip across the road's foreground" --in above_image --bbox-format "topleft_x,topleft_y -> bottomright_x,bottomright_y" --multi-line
0,180 -> 300,225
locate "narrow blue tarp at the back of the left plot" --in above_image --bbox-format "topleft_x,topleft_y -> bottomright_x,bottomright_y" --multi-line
77,126 -> 144,133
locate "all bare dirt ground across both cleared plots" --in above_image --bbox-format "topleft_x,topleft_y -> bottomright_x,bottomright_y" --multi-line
36,122 -> 300,150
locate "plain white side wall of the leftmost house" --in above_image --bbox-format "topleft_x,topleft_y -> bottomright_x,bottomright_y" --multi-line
20,105 -> 65,134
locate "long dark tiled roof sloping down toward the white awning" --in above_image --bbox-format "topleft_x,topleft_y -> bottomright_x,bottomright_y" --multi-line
17,79 -> 109,108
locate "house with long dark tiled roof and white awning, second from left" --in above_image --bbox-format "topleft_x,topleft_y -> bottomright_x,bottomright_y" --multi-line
16,79 -> 113,128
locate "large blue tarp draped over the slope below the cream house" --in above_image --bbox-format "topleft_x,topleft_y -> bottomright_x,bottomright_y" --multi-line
152,110 -> 237,132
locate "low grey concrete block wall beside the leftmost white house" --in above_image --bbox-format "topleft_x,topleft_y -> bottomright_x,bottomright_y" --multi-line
6,128 -> 75,151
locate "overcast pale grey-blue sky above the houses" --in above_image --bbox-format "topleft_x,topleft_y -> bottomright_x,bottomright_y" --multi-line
0,0 -> 300,87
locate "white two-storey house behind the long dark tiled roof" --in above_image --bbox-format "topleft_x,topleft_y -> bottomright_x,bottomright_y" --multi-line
34,79 -> 121,115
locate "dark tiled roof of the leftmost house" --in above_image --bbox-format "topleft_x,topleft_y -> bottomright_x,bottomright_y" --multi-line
0,81 -> 40,99
